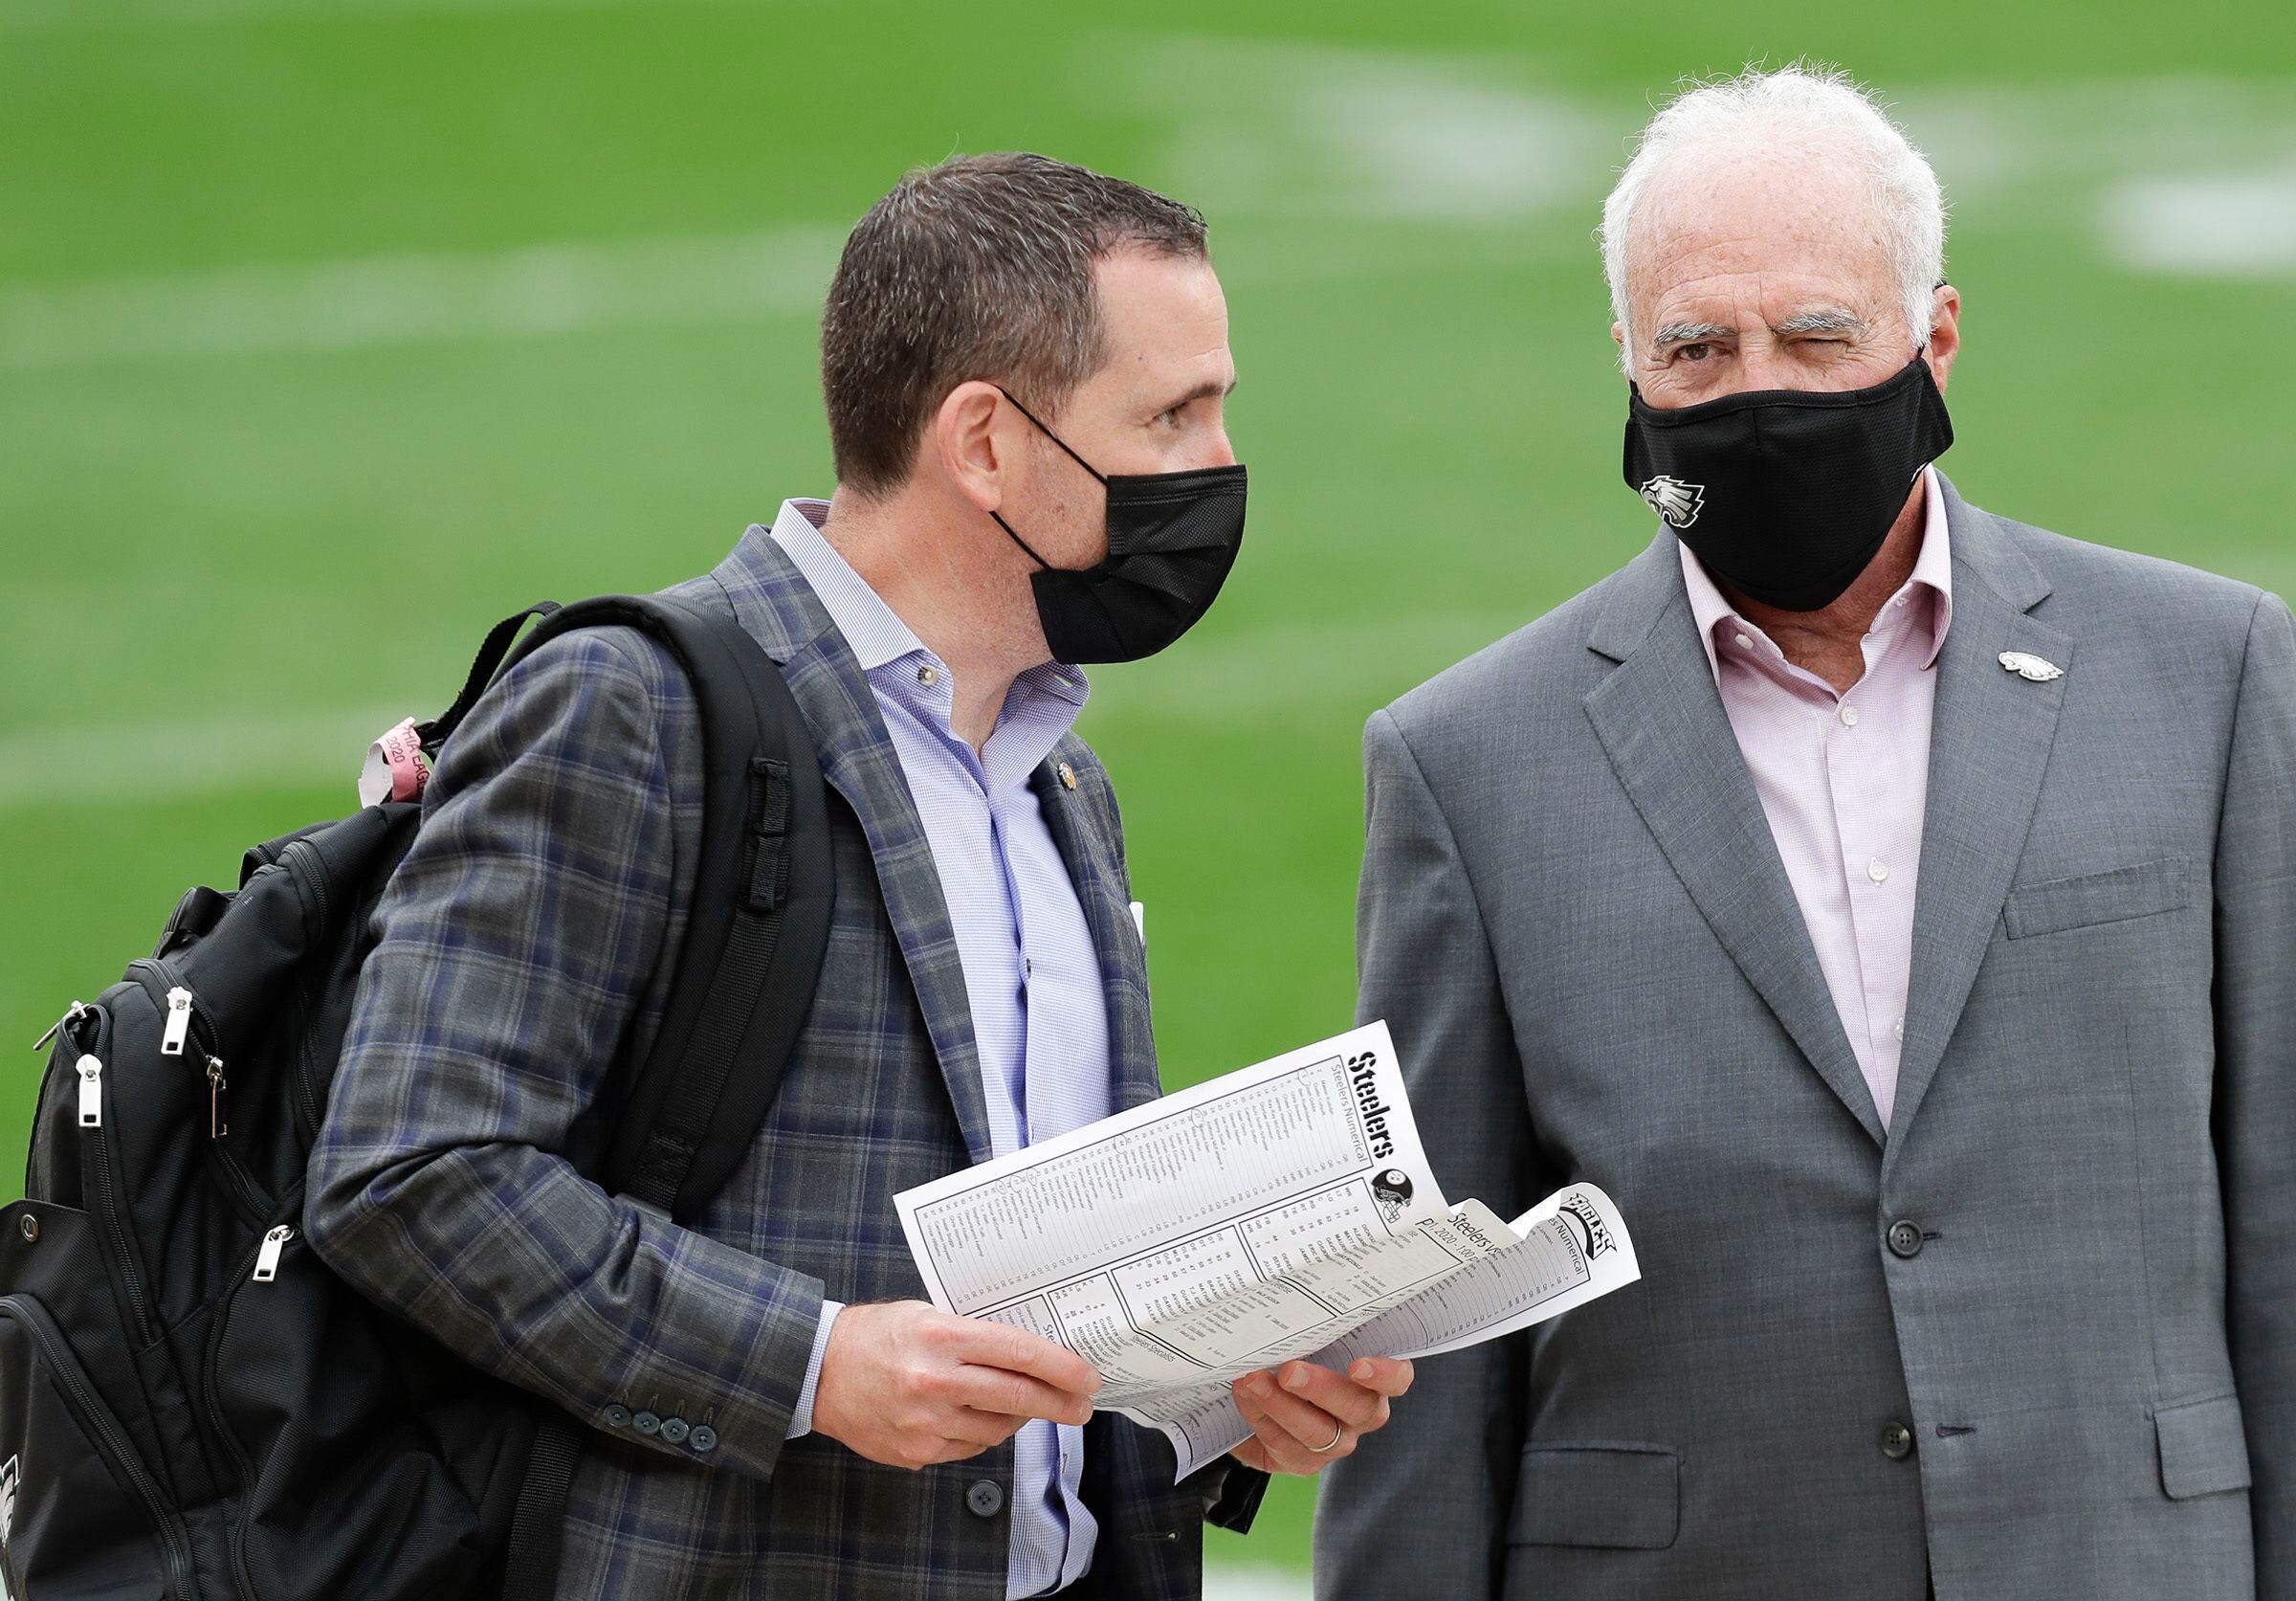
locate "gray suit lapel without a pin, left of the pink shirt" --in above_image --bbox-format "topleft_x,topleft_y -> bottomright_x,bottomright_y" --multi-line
1586,533 -> 1883,1144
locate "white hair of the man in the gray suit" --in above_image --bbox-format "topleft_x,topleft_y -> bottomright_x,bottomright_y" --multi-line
1601,62 -> 1945,365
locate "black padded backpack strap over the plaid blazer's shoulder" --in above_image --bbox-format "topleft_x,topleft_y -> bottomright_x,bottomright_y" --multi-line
477,595 -> 836,1601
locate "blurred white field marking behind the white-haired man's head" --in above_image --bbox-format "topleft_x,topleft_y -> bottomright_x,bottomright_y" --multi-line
1106,34 -> 2296,278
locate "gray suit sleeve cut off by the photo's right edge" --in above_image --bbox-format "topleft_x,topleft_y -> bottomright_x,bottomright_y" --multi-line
2216,595 -> 2296,1601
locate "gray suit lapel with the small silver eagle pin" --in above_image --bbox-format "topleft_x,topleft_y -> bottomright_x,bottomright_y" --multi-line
1889,480 -> 2073,1167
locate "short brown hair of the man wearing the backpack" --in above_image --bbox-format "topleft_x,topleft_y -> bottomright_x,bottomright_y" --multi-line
822,154 -> 1205,494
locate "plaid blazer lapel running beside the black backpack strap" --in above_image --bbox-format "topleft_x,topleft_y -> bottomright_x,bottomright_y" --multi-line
712,528 -> 994,1163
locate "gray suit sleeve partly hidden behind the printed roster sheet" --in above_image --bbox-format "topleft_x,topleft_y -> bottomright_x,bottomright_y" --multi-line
1315,712 -> 1538,1601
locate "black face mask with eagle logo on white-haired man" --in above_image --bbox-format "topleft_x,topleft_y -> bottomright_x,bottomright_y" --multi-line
1625,354 -> 1954,611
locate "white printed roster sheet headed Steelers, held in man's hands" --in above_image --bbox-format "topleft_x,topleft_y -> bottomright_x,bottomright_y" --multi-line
894,1022 -> 1640,1477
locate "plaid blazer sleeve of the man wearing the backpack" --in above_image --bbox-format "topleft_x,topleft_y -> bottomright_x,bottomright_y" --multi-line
305,632 -> 822,1479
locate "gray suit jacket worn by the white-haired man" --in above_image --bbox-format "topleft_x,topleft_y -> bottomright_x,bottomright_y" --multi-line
1315,475 -> 2296,1601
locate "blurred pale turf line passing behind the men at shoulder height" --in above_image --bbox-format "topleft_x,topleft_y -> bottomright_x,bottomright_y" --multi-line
0,613 -> 1527,811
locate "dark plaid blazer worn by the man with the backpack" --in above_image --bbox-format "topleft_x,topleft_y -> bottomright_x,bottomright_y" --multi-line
305,528 -> 1258,1601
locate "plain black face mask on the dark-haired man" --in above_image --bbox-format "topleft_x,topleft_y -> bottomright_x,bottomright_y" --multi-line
989,390 -> 1245,661
